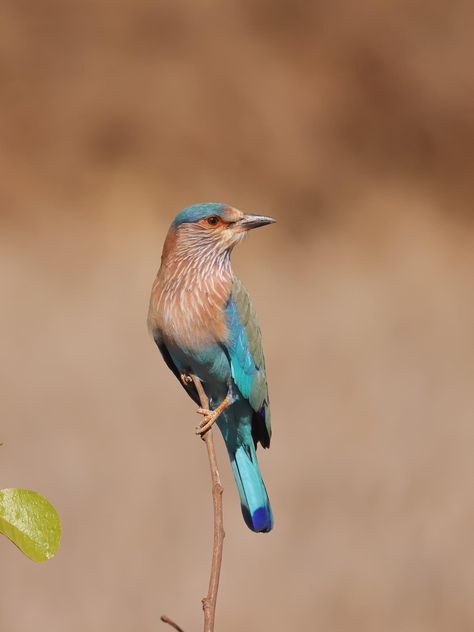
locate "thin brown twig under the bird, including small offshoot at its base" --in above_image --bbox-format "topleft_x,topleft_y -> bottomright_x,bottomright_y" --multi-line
161,375 -> 225,632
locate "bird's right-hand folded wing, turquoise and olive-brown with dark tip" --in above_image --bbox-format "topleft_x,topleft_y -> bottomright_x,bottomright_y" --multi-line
226,279 -> 271,448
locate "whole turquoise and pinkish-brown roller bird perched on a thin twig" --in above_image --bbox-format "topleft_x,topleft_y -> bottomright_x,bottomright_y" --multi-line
148,203 -> 275,533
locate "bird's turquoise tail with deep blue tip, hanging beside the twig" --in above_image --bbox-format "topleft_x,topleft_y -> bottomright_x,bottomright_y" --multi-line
228,436 -> 273,533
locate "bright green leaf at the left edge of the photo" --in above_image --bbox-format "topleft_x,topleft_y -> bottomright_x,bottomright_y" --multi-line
0,489 -> 61,562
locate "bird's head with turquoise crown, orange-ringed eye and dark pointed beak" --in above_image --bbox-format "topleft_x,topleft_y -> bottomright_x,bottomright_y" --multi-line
170,202 -> 276,254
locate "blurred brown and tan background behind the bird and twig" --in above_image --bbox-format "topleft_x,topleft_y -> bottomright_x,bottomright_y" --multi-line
0,0 -> 474,632
